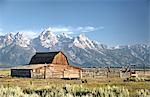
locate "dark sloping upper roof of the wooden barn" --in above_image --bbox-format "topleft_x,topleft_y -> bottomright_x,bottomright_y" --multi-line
29,51 -> 60,64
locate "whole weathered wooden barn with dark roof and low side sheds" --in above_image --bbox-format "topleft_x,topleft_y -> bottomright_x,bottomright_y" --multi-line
11,51 -> 82,79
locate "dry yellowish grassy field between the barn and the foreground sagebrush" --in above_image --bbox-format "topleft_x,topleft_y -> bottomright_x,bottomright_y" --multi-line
0,70 -> 150,97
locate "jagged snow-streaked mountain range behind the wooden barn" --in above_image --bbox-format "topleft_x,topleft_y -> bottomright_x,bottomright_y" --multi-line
0,29 -> 150,67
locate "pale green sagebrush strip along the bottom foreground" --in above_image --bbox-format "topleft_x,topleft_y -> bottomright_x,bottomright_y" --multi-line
0,84 -> 150,97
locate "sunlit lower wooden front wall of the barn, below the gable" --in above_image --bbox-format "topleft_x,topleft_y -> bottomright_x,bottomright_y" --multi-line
32,64 -> 82,78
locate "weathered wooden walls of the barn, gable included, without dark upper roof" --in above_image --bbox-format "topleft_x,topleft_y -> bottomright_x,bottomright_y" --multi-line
12,52 -> 82,78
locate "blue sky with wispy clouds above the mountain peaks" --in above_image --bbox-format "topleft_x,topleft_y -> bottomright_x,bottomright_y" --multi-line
0,0 -> 150,46
